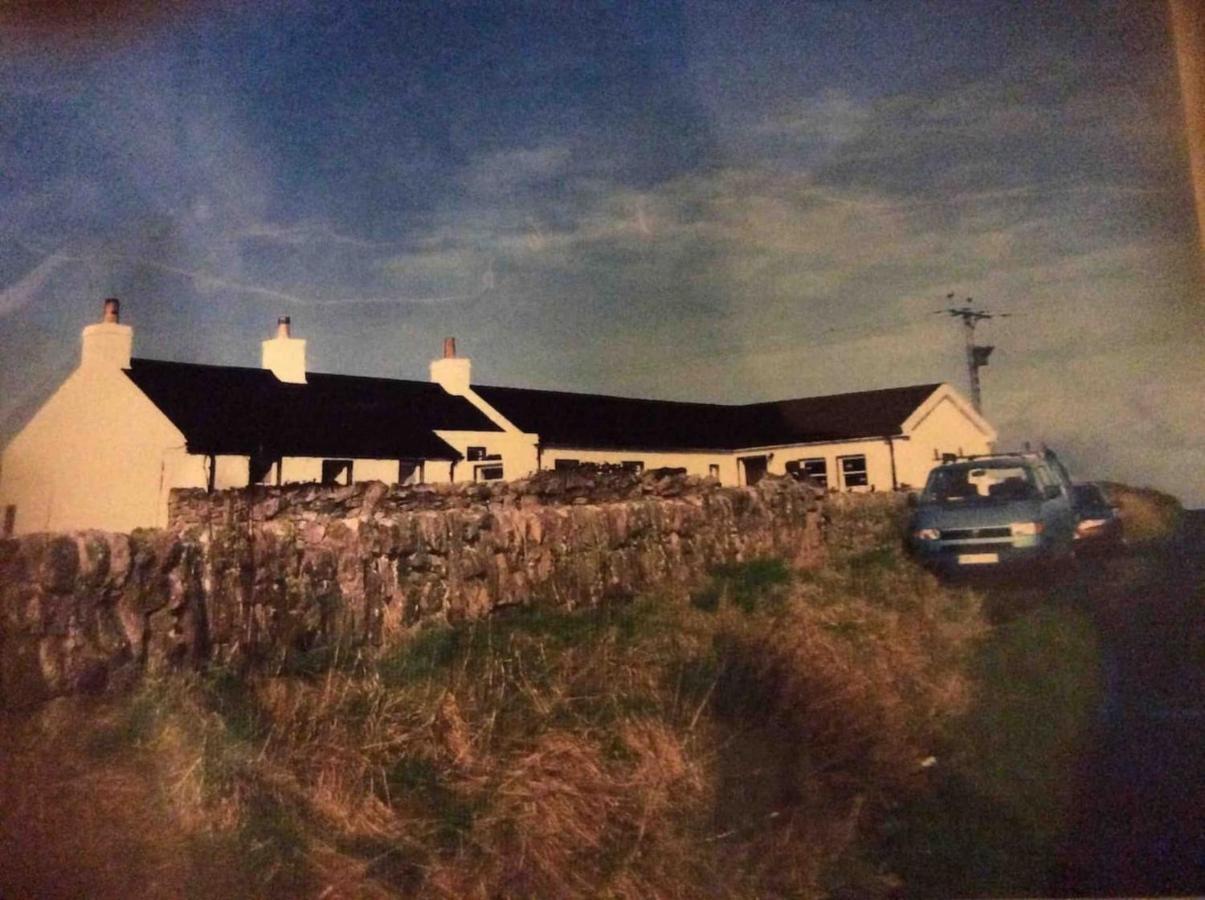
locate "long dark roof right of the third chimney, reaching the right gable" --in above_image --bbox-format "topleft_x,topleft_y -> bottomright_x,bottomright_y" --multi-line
474,384 -> 941,451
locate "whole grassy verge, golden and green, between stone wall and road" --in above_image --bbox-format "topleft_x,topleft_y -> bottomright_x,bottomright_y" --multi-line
0,489 -> 1113,900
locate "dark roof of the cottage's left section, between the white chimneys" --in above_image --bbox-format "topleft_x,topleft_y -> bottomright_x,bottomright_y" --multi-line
125,359 -> 500,459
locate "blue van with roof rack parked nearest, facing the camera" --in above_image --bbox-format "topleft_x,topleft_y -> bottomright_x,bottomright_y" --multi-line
907,451 -> 1078,573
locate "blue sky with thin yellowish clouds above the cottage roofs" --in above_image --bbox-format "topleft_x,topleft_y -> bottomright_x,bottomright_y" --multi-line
0,0 -> 1205,505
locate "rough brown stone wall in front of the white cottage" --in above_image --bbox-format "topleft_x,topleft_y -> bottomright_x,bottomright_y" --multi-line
0,471 -> 823,707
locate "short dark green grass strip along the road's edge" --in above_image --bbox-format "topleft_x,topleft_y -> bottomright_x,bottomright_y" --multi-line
878,595 -> 1103,898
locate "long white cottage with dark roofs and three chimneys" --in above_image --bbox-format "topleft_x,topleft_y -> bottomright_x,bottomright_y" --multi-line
0,300 -> 995,535
